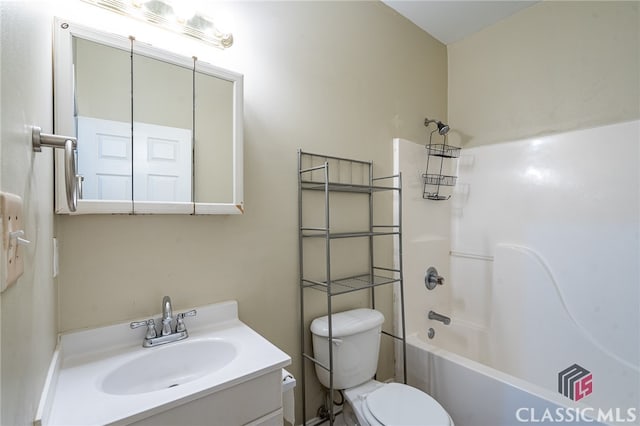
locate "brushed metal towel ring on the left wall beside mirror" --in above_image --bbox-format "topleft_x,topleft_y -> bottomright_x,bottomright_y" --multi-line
31,126 -> 78,212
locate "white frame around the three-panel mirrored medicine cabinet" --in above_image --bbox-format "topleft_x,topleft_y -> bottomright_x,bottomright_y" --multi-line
53,17 -> 244,215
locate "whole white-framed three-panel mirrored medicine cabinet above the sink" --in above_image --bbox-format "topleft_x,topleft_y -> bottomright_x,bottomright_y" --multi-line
54,19 -> 243,214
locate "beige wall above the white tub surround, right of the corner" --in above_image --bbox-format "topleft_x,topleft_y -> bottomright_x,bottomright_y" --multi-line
448,1 -> 640,146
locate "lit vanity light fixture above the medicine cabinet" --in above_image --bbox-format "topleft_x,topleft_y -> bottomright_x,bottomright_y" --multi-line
83,0 -> 233,49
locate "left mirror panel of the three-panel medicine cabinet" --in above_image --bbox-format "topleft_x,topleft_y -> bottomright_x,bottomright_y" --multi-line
73,37 -> 133,201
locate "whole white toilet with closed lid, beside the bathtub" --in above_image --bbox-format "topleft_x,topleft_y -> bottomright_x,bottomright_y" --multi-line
311,309 -> 453,426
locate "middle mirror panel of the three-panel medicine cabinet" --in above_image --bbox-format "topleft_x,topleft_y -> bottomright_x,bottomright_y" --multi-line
132,43 -> 194,213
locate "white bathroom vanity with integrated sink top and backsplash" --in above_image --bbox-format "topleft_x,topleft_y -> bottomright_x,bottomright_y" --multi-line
34,301 -> 291,426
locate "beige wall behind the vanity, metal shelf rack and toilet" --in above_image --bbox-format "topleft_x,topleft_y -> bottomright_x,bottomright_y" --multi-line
56,2 -> 447,420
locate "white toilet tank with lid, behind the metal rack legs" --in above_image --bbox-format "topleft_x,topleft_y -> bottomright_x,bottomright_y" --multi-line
311,309 -> 384,389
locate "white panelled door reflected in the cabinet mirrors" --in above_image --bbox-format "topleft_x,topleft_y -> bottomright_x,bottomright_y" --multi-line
78,117 -> 192,203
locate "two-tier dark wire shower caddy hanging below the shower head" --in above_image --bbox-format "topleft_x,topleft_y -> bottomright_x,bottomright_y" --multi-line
422,118 -> 460,201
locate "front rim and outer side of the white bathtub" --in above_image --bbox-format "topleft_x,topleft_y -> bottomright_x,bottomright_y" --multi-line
407,332 -> 640,426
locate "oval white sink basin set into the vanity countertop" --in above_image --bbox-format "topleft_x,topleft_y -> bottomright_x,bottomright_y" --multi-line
100,339 -> 237,395
